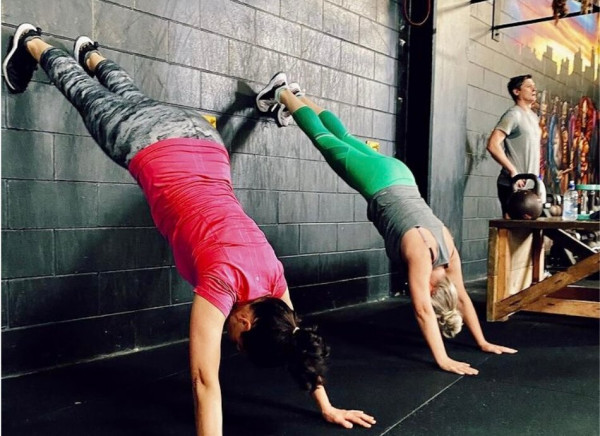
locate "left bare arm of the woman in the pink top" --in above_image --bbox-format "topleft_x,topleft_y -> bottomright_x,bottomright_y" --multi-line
190,295 -> 225,436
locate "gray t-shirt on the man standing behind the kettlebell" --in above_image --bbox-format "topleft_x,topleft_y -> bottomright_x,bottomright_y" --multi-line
496,105 -> 542,186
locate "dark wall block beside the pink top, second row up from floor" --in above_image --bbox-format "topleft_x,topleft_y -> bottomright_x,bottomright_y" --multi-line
98,268 -> 171,315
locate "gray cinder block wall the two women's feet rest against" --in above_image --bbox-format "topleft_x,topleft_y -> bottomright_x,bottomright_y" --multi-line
2,0 -> 401,376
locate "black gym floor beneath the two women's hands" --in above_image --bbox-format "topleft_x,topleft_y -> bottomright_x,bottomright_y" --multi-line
2,282 -> 600,436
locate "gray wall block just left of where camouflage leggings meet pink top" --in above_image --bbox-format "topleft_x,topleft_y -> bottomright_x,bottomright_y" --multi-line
54,135 -> 135,184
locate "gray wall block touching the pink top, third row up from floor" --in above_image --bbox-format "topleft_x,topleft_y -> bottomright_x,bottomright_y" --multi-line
55,228 -> 171,274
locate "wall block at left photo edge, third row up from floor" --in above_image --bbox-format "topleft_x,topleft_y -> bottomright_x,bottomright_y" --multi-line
2,230 -> 54,279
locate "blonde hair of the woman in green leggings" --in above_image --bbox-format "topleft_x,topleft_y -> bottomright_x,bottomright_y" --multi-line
431,276 -> 463,338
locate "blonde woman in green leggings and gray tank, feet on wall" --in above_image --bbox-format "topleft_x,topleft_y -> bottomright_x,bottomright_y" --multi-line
256,73 -> 517,375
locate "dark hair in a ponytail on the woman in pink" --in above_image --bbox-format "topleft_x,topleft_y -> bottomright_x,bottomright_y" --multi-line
241,298 -> 329,392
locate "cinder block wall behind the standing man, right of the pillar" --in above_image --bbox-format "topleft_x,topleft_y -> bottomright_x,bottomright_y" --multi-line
461,2 -> 599,279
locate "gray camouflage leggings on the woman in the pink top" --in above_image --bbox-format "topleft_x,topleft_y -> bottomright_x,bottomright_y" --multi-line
40,48 -> 223,168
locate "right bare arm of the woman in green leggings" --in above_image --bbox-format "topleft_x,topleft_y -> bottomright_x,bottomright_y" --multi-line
444,228 -> 517,354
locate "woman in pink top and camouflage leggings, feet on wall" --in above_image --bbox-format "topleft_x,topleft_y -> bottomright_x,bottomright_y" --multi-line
3,24 -> 375,435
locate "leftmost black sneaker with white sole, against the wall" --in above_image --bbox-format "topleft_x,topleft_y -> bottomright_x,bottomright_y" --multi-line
2,23 -> 42,94
